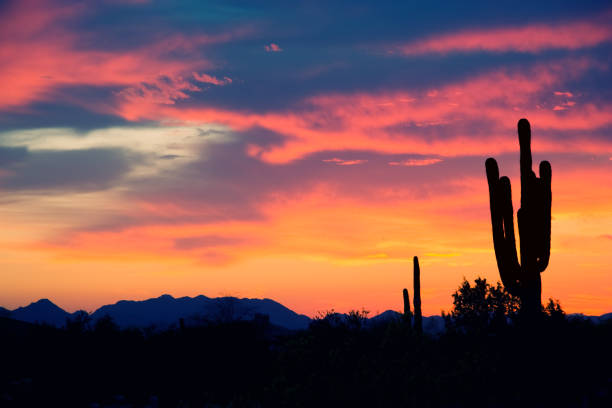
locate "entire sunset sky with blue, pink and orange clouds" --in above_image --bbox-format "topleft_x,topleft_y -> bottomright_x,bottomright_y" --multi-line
0,0 -> 612,316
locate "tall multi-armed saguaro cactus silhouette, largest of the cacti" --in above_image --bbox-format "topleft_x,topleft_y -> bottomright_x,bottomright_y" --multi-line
485,119 -> 552,315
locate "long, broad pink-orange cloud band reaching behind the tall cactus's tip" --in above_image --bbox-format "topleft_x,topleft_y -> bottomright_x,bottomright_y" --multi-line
117,59 -> 612,163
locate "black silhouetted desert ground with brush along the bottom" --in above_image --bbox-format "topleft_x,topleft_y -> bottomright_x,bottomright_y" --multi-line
0,318 -> 612,407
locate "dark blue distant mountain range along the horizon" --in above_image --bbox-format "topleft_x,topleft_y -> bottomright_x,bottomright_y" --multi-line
0,295 -> 612,334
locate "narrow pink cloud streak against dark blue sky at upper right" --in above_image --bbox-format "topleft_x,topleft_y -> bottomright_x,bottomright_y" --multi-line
397,20 -> 612,55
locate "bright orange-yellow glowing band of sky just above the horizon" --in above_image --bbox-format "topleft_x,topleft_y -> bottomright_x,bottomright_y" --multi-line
2,162 -> 612,316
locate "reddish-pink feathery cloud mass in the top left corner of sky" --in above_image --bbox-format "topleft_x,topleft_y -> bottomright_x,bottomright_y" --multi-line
0,0 -> 248,109
